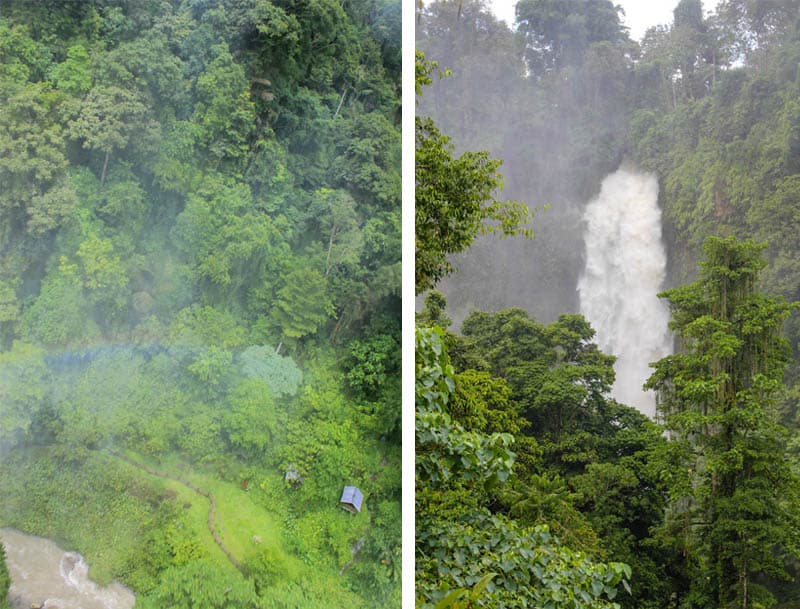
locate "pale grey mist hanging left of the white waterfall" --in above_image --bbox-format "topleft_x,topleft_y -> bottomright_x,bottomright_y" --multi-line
417,2 -> 628,326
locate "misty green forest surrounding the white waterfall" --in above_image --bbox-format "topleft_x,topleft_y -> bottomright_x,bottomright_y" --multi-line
417,0 -> 800,609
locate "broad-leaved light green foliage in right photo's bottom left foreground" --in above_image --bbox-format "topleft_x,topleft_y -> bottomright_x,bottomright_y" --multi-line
415,328 -> 631,609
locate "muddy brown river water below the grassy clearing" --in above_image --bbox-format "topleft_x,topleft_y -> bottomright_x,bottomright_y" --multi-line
0,528 -> 135,609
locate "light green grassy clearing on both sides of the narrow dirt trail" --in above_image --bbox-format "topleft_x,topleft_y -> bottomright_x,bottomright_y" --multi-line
0,448 -> 363,609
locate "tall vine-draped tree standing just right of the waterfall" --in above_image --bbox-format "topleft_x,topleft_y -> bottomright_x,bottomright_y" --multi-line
646,237 -> 800,608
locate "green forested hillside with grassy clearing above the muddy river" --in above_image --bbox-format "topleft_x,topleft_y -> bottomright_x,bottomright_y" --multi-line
0,0 -> 401,608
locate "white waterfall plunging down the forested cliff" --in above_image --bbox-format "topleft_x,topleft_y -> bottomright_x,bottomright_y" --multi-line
578,167 -> 672,418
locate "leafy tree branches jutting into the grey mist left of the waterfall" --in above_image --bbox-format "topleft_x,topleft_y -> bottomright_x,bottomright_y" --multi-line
414,51 -> 532,293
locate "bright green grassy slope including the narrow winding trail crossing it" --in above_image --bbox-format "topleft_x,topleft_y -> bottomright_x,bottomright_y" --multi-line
0,444 -> 369,606
